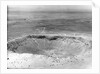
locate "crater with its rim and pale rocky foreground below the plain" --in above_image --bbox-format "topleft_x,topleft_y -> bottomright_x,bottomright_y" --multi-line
7,34 -> 92,69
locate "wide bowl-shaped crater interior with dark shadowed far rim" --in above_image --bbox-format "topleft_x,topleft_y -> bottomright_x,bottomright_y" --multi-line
7,35 -> 91,58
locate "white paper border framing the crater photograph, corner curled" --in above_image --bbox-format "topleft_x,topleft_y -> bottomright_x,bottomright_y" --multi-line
1,1 -> 100,73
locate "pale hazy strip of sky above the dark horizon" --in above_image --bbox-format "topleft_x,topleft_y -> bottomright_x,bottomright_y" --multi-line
8,5 -> 92,12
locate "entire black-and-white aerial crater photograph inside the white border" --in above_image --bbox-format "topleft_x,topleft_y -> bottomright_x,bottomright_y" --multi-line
7,5 -> 92,69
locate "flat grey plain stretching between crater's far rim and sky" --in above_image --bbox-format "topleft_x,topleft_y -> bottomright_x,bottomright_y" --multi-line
7,11 -> 92,40
